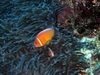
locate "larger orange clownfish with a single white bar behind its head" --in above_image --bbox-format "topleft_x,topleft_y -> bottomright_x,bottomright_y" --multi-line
34,28 -> 54,47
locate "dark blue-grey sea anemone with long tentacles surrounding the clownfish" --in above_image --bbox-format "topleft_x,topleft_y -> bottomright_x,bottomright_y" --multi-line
0,0 -> 94,75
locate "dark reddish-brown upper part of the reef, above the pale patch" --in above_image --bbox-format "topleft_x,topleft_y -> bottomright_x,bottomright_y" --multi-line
58,0 -> 100,38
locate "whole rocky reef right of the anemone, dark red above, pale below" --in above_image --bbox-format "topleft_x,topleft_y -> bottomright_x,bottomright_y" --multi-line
58,0 -> 100,75
